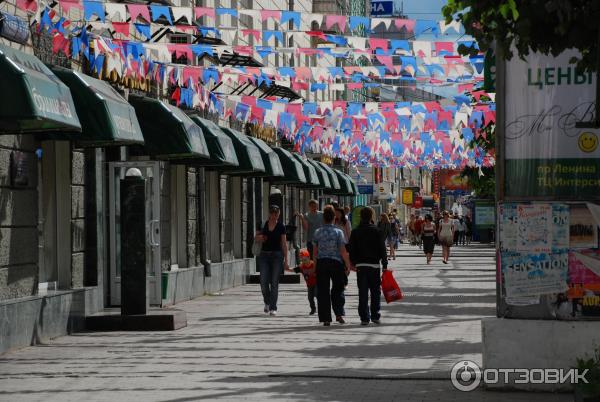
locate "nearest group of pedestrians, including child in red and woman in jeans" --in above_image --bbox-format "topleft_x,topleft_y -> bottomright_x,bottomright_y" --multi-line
255,200 -> 395,326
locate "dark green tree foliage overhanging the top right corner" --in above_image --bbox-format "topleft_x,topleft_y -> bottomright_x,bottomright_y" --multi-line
443,0 -> 600,71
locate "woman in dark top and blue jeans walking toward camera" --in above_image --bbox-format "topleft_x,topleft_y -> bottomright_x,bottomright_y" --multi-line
256,205 -> 289,316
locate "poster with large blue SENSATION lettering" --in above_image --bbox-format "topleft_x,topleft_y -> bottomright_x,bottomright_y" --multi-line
502,249 -> 569,298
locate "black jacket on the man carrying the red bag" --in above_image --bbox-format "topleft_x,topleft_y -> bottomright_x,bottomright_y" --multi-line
349,223 -> 387,268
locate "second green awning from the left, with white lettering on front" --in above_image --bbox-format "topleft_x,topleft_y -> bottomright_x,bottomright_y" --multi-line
52,67 -> 144,146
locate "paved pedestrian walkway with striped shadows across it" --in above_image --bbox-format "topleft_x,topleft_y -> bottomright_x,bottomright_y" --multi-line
0,245 -> 572,402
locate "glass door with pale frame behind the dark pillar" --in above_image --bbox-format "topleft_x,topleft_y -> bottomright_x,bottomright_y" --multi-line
108,162 -> 161,306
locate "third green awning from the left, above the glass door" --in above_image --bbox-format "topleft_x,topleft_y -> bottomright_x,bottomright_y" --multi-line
129,96 -> 210,160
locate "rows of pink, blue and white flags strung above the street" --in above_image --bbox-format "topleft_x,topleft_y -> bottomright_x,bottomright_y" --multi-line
9,0 -> 495,168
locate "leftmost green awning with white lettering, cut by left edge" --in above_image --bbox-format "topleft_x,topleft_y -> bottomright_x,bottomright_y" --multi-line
0,43 -> 81,134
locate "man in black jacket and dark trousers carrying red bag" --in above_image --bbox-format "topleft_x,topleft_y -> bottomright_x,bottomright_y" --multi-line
350,207 -> 388,325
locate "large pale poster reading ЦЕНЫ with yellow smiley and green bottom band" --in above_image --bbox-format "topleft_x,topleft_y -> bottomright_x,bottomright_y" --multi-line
504,51 -> 600,200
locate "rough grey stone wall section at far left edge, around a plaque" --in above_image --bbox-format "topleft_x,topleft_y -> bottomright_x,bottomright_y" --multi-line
0,135 -> 39,300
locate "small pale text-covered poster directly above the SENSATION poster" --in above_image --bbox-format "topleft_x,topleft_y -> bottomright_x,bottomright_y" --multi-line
516,204 -> 553,253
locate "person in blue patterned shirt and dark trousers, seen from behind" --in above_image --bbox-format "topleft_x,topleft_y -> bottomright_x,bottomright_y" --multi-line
313,205 -> 352,326
